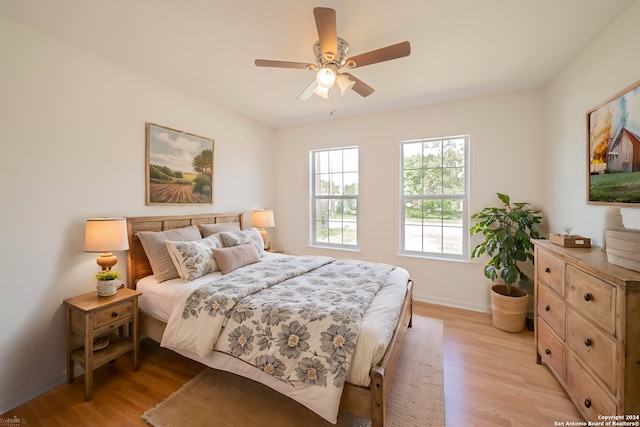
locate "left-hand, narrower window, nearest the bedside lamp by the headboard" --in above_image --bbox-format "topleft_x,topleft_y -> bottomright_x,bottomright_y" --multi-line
311,147 -> 359,249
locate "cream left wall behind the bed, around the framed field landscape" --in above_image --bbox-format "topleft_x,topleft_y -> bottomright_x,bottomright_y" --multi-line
0,18 -> 274,413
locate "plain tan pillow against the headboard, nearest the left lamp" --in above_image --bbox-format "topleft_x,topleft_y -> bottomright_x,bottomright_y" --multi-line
136,225 -> 202,282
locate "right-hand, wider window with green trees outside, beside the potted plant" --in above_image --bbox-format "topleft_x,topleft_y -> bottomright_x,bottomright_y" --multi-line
400,136 -> 469,259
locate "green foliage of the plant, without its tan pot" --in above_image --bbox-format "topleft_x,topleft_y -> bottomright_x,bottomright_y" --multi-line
469,193 -> 542,295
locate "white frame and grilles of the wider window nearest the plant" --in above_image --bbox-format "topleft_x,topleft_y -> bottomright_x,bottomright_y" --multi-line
398,135 -> 471,261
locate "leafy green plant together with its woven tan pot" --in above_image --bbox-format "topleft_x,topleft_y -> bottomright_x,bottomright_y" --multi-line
469,193 -> 542,332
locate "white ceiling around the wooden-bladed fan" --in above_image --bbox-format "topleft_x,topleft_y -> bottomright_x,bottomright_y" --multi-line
0,0 -> 633,128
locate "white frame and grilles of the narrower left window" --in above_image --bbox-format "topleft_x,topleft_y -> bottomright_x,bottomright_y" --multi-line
309,145 -> 361,251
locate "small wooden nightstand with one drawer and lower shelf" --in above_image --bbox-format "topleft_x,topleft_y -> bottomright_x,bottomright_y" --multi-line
64,288 -> 141,402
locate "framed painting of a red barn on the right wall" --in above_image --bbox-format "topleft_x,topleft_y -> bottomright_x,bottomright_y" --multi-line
587,80 -> 640,206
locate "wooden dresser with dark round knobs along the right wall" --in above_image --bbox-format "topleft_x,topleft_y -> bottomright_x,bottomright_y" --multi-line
534,240 -> 640,421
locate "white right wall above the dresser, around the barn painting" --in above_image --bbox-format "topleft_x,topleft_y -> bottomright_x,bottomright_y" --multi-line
544,1 -> 640,246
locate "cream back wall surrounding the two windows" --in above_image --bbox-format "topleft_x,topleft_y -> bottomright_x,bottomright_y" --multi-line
274,92 -> 544,311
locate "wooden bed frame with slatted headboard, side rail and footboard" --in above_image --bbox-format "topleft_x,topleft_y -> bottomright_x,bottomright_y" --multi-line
127,213 -> 413,427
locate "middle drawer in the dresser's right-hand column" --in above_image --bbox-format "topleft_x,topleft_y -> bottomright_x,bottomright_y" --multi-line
567,308 -> 617,393
